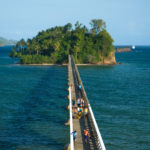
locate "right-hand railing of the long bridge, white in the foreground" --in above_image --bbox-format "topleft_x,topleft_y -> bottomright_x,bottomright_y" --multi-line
72,57 -> 106,150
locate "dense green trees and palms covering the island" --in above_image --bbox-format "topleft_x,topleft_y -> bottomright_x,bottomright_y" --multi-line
10,19 -> 114,64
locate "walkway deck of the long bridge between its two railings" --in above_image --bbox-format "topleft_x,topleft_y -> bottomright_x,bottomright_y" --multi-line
68,56 -> 100,150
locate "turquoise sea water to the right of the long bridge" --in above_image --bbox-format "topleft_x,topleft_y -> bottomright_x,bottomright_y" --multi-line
79,47 -> 150,150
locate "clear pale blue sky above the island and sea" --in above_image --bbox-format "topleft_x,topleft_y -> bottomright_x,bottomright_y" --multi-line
0,0 -> 150,45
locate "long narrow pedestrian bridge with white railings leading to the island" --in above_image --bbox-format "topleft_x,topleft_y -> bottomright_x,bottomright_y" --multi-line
68,55 -> 106,150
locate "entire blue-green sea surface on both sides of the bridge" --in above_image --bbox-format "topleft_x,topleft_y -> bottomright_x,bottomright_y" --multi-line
0,46 -> 150,150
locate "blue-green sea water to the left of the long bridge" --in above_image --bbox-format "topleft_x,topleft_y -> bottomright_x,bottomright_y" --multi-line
0,47 -> 69,150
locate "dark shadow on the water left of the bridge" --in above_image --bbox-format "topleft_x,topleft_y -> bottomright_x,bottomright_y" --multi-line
0,67 -> 67,150
